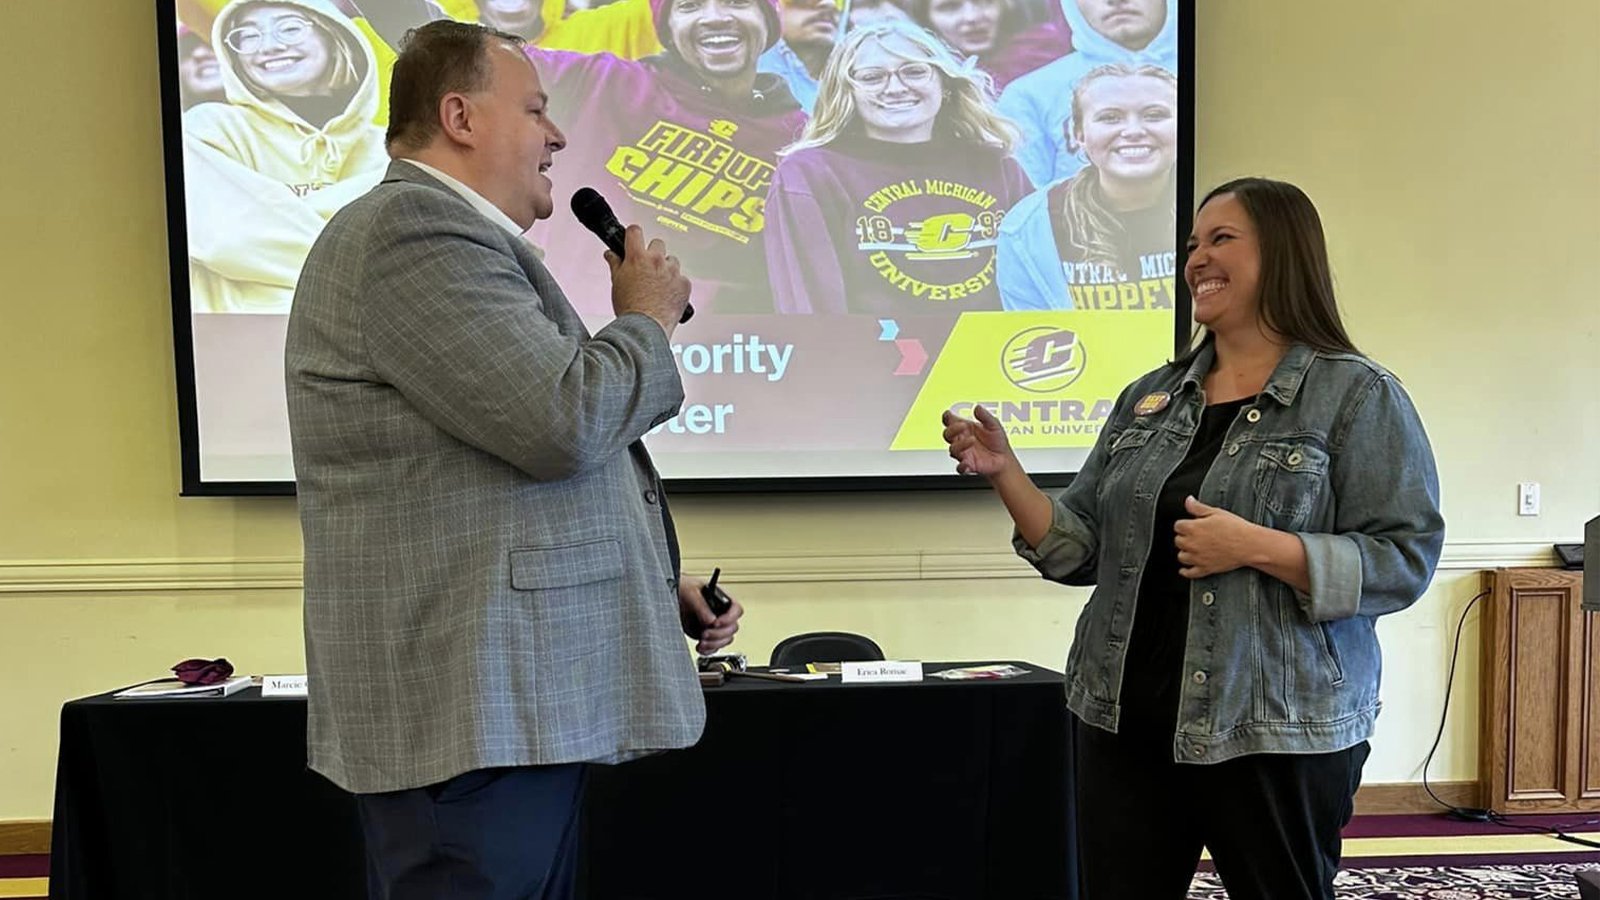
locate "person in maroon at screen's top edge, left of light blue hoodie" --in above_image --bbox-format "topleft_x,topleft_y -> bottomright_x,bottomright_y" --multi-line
910,0 -> 1072,93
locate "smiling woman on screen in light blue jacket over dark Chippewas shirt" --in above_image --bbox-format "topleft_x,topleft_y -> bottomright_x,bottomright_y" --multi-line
998,66 -> 1178,312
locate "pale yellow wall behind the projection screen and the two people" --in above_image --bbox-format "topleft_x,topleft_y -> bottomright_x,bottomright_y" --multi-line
0,0 -> 1600,820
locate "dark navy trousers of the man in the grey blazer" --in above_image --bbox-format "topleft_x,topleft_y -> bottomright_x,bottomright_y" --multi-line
355,764 -> 586,900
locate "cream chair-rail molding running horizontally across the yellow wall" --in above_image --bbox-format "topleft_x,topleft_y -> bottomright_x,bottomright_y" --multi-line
0,541 -> 1555,594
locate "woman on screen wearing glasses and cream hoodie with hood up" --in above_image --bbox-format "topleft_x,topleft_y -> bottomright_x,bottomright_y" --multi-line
182,0 -> 389,314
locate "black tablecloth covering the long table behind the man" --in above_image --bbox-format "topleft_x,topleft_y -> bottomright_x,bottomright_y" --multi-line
50,663 -> 1077,900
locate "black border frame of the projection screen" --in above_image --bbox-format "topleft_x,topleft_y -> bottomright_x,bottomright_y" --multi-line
155,0 -> 1195,496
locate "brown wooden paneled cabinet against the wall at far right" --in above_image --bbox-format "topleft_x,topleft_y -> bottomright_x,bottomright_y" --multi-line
1478,569 -> 1600,814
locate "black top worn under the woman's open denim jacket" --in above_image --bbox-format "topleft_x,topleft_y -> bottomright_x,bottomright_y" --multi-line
1117,397 -> 1256,745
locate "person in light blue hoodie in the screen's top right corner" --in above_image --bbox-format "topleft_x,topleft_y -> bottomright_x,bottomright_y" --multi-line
1000,0 -> 1178,184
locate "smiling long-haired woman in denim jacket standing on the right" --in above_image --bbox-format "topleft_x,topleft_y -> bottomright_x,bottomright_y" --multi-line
944,179 -> 1445,900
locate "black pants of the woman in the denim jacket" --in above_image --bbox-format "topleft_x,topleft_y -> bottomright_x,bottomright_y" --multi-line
1072,717 -> 1370,900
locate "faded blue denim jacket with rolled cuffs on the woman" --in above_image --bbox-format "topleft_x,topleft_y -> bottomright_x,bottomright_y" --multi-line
1013,344 -> 1445,762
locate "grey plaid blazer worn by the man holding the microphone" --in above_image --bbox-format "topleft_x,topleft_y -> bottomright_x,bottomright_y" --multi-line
285,162 -> 706,793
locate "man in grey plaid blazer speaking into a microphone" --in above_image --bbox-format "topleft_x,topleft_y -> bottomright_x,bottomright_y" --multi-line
285,21 -> 742,898
